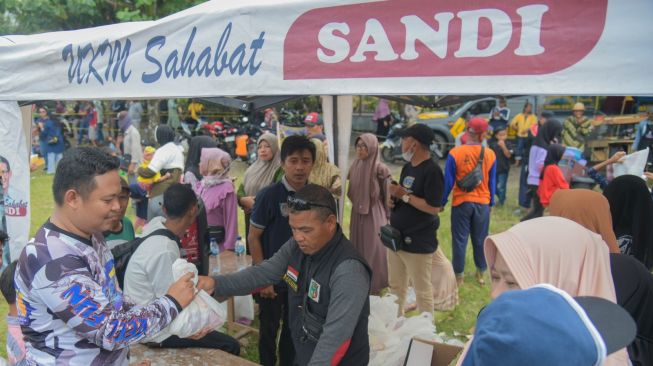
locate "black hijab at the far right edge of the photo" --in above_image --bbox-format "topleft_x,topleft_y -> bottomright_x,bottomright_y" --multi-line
603,175 -> 653,270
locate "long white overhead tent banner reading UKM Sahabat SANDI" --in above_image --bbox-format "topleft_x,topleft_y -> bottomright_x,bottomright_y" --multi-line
0,0 -> 653,100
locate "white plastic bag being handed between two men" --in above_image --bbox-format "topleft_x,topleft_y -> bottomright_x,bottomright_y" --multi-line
168,259 -> 227,338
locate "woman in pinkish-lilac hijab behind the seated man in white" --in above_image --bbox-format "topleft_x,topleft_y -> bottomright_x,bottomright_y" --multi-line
194,148 -> 238,250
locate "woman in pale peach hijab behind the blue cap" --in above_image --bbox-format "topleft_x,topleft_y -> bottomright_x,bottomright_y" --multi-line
459,216 -> 628,366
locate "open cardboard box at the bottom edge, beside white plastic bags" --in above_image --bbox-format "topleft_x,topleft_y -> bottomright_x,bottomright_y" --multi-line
404,338 -> 463,366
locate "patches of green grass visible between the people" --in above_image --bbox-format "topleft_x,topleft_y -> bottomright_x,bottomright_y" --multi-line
0,162 -> 518,361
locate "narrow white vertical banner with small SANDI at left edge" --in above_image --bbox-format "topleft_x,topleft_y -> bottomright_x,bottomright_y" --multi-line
0,102 -> 30,260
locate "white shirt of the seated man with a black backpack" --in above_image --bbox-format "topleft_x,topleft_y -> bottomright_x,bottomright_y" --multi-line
124,216 -> 180,343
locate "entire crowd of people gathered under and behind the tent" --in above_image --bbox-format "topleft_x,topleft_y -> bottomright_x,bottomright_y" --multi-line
0,98 -> 653,365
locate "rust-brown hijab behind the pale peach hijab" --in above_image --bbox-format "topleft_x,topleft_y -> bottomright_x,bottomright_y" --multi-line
549,189 -> 620,253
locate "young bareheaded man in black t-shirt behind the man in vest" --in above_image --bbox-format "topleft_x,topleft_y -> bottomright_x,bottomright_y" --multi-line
247,135 -> 315,366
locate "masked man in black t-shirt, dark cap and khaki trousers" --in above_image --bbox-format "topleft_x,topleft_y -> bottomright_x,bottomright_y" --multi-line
388,124 -> 444,314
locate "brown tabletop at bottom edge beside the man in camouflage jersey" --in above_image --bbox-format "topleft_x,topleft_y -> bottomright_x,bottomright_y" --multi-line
129,344 -> 256,366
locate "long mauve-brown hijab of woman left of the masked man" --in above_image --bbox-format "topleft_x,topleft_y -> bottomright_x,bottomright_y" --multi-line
347,133 -> 382,215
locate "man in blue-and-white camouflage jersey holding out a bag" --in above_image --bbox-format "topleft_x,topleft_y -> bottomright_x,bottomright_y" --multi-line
14,148 -> 194,366
